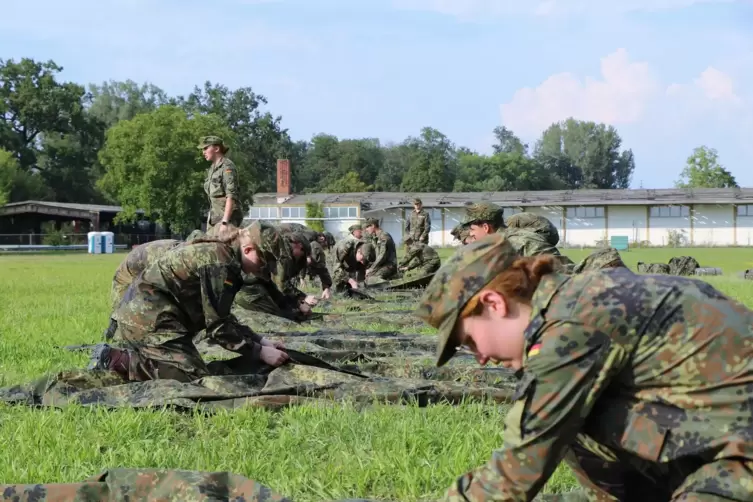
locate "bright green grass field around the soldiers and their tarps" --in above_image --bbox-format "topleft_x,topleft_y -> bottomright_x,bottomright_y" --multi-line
0,248 -> 753,501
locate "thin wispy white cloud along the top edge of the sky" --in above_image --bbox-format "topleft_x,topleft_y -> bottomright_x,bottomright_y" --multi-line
392,0 -> 745,20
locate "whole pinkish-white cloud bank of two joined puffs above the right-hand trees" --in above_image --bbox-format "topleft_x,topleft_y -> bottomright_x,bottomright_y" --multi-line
500,49 -> 753,137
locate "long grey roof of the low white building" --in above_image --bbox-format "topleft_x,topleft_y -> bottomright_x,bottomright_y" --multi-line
254,188 -> 753,211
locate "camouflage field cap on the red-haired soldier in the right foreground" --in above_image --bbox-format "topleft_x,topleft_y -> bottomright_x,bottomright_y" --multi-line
415,233 -> 520,366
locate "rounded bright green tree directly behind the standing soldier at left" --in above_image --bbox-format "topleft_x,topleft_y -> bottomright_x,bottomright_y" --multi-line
99,105 -> 232,231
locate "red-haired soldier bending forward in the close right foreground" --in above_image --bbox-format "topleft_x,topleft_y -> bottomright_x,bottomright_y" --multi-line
416,234 -> 753,502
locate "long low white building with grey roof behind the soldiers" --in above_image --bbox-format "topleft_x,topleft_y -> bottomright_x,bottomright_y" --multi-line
248,188 -> 753,247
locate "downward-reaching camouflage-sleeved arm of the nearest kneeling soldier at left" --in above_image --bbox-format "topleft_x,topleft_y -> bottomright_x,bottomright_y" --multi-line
199,265 -> 261,359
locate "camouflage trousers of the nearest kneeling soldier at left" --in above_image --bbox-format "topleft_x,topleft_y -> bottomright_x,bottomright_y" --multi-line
114,321 -> 271,382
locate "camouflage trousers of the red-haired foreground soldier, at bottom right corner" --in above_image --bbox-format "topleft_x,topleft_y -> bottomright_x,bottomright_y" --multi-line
564,437 -> 753,502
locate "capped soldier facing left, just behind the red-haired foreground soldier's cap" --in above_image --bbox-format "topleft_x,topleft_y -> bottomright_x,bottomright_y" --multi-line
463,202 -> 574,267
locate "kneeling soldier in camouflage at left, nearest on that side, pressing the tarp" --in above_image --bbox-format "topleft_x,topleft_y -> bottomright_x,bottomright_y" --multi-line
89,223 -> 289,382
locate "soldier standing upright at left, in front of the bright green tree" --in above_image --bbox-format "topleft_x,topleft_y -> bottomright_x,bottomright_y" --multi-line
199,136 -> 243,234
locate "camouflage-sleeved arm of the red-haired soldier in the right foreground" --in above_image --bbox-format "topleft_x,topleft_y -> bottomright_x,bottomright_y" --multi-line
443,321 -> 627,502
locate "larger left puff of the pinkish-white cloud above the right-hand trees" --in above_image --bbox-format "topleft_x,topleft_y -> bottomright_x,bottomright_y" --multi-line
501,49 -> 659,136
